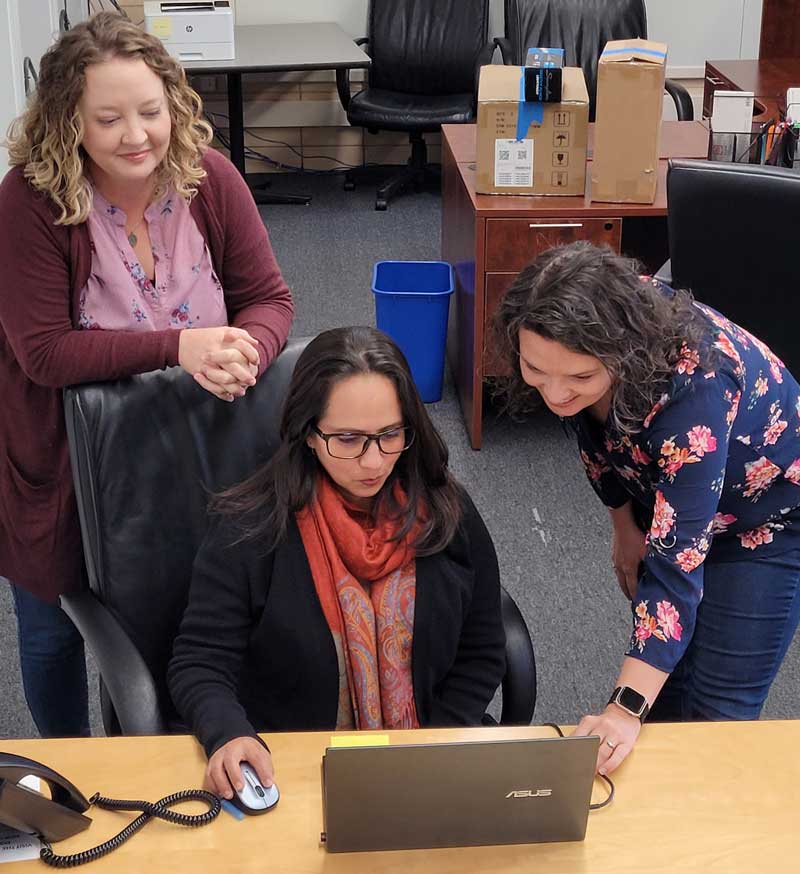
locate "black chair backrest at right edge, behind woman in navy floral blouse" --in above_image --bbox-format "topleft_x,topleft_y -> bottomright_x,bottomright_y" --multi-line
667,160 -> 800,378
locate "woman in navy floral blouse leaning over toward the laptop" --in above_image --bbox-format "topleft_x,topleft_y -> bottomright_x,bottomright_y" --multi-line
497,243 -> 800,773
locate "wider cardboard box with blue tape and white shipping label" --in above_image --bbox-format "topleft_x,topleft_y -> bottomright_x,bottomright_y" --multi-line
476,64 -> 589,195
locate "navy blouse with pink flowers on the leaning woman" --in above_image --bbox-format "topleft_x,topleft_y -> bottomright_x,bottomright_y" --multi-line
570,289 -> 800,673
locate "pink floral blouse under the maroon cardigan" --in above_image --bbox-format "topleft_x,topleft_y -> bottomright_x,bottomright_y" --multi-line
79,184 -> 228,331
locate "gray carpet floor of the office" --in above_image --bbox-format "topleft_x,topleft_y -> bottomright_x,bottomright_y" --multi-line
0,170 -> 800,738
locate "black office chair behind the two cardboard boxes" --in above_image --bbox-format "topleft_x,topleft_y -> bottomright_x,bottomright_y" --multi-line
495,0 -> 694,121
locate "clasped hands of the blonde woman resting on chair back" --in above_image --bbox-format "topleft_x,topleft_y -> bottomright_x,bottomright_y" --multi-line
178,327 -> 260,402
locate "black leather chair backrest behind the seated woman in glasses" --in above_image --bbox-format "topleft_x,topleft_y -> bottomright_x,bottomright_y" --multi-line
64,339 -> 308,724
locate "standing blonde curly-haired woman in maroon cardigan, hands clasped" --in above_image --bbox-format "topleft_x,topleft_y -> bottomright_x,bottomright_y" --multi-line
0,13 -> 293,736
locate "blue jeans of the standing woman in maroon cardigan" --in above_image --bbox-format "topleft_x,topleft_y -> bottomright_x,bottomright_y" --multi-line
11,583 -> 90,737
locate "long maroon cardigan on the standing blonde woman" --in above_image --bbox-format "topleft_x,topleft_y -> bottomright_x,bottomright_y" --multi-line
0,150 -> 293,600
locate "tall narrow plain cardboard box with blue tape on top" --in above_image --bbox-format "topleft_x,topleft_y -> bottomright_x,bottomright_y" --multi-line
591,39 -> 667,203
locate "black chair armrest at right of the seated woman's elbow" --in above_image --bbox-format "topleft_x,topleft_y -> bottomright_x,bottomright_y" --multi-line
500,589 -> 536,725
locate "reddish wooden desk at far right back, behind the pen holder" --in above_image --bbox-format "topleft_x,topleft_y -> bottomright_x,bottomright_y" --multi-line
703,58 -> 800,122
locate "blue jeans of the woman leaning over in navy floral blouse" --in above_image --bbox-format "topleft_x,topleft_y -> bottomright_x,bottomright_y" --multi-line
648,531 -> 800,722
